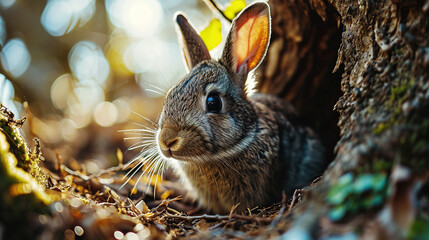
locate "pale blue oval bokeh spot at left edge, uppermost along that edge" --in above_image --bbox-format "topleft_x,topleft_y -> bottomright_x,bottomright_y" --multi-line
1,38 -> 31,77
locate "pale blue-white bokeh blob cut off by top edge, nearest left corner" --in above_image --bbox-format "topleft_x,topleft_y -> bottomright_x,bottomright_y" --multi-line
40,0 -> 95,37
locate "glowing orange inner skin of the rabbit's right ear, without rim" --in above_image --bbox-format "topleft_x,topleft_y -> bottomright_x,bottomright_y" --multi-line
233,11 -> 269,72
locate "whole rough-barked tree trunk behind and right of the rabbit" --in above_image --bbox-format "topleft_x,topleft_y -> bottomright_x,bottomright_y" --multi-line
260,0 -> 429,238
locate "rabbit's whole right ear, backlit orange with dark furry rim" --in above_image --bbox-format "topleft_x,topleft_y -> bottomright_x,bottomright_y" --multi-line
220,2 -> 271,84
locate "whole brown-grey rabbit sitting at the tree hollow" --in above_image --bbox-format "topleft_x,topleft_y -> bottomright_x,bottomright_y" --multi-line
150,2 -> 325,213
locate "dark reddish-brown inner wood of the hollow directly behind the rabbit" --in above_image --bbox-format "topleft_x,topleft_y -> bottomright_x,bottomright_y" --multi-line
258,0 -> 341,160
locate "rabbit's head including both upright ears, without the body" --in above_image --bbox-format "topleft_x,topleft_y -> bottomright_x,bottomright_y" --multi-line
156,2 -> 271,162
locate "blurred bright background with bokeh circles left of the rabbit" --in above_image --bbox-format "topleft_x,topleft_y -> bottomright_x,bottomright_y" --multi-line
0,0 -> 229,173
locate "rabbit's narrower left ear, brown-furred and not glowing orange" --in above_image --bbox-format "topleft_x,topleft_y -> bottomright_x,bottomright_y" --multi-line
175,13 -> 211,71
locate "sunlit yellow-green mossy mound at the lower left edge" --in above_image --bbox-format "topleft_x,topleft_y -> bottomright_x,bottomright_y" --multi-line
0,108 -> 57,239
